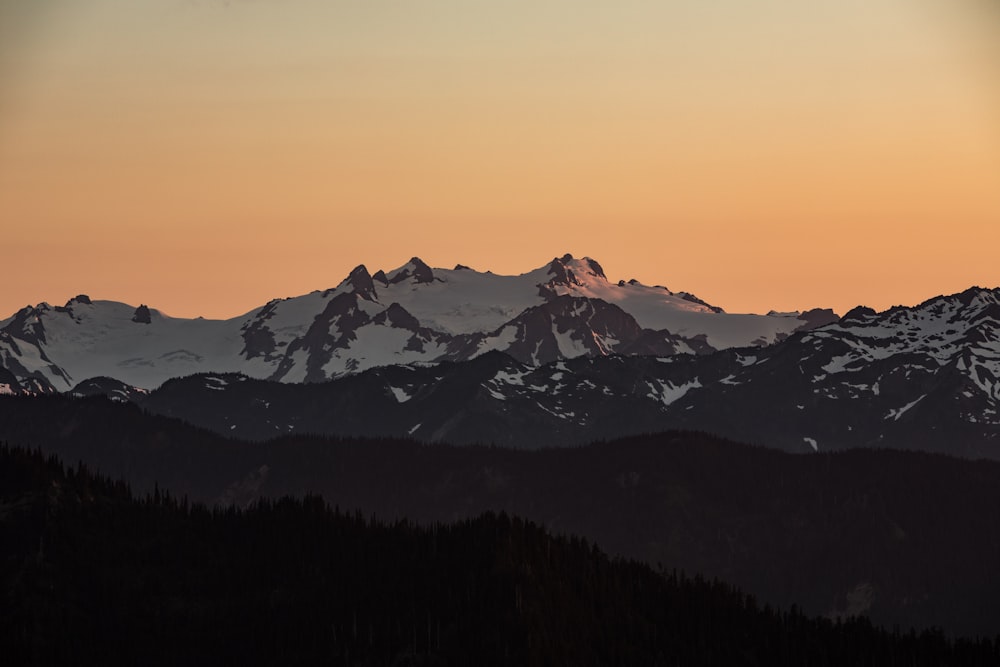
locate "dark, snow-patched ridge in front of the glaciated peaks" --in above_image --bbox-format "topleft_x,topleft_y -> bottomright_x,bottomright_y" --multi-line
66,288 -> 1000,459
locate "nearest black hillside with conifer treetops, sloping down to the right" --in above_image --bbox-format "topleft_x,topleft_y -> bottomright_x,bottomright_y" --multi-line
0,448 -> 1000,666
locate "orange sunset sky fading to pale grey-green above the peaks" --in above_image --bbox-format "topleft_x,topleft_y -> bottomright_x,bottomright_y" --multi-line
0,0 -> 1000,319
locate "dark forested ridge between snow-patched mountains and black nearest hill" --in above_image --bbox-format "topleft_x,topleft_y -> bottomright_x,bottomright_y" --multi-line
0,396 -> 1000,636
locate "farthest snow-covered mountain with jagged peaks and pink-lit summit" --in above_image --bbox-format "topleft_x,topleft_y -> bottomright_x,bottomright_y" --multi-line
0,255 -> 836,393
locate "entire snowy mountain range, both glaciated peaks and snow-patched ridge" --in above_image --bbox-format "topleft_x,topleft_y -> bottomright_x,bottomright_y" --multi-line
0,255 -> 1000,459
